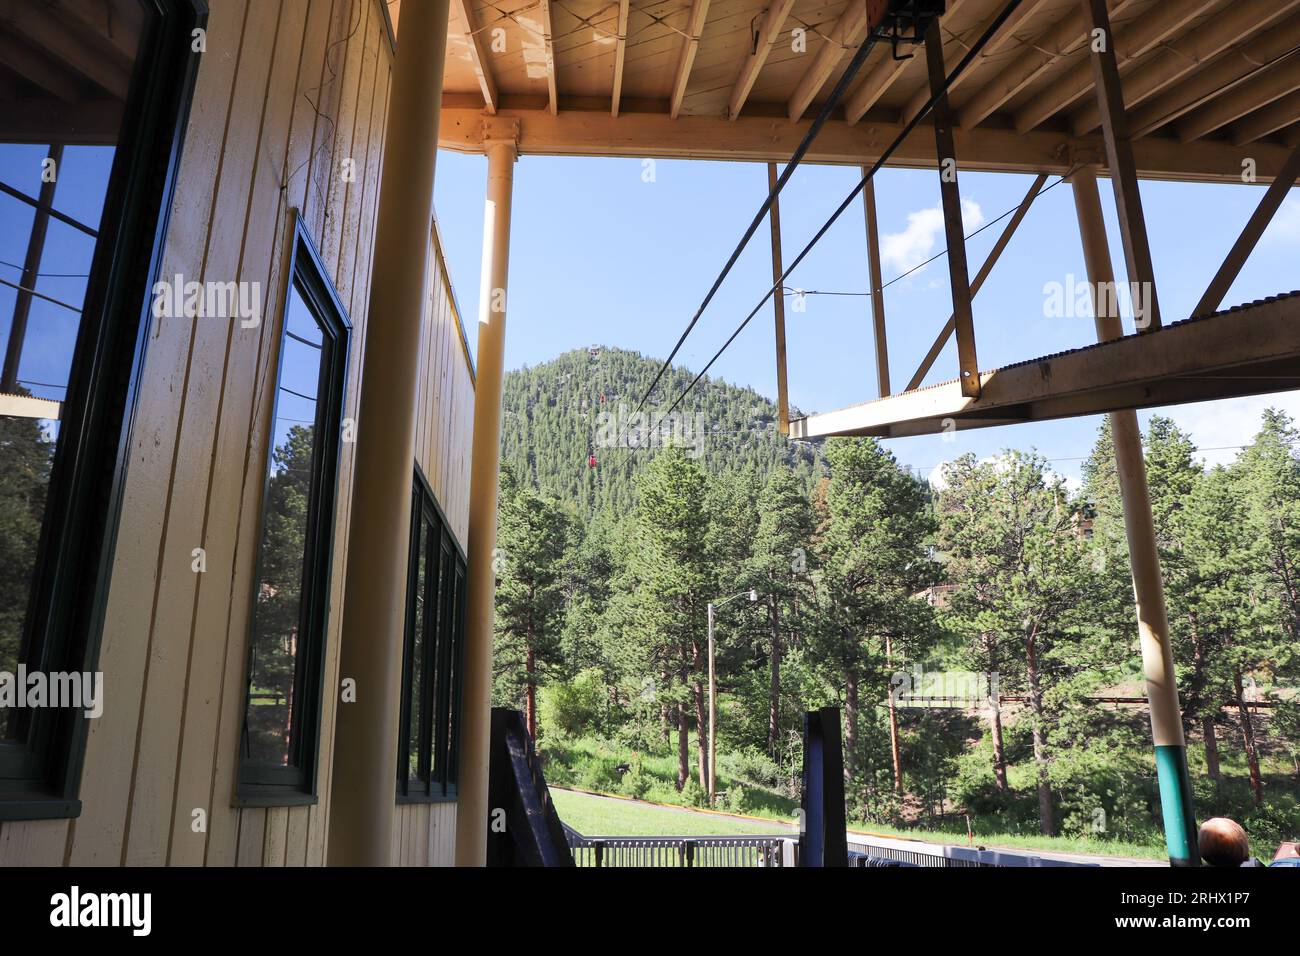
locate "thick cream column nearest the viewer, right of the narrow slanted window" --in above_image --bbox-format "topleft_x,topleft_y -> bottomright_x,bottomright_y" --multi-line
325,0 -> 447,866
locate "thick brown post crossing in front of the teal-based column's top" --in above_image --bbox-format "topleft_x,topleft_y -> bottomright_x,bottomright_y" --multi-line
1080,0 -> 1160,332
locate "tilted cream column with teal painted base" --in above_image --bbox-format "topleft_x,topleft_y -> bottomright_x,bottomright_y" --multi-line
1071,166 -> 1200,866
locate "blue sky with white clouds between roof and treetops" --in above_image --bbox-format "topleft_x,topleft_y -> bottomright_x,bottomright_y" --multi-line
436,151 -> 1300,489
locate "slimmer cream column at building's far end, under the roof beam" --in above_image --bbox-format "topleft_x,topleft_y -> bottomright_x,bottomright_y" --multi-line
456,127 -> 517,866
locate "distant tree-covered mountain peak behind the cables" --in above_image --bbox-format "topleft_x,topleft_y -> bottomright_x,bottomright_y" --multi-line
502,347 -> 824,516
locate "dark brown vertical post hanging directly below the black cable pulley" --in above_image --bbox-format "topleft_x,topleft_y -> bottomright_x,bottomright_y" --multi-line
926,17 -> 980,398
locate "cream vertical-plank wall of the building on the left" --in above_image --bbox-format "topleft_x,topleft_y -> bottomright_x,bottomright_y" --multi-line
0,0 -> 473,866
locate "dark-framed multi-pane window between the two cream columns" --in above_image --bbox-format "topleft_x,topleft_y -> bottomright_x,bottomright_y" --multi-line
398,467 -> 465,801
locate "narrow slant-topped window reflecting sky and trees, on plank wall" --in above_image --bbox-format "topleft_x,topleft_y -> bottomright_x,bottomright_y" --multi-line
238,212 -> 352,806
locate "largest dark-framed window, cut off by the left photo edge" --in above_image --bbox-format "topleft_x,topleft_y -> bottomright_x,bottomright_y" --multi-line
0,0 -> 207,819
